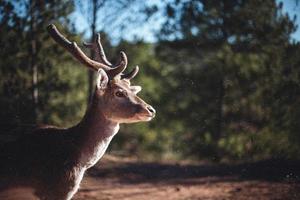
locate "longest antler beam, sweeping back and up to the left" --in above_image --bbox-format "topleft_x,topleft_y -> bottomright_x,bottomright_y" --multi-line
47,24 -> 111,71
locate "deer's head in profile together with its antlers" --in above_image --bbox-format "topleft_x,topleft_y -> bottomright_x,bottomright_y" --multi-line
48,24 -> 155,123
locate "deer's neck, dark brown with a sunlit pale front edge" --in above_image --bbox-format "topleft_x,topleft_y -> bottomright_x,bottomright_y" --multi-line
76,98 -> 119,168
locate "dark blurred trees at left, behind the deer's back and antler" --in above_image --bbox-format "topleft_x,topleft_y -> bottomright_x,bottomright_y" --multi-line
0,1 -> 85,127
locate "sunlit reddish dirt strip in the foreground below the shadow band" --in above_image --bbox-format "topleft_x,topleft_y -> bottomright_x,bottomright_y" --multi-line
75,177 -> 300,200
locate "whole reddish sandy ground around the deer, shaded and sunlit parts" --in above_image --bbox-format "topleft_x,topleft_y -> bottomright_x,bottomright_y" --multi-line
0,156 -> 300,200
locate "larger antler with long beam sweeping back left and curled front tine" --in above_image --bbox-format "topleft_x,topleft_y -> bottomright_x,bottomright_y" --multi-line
47,24 -> 127,79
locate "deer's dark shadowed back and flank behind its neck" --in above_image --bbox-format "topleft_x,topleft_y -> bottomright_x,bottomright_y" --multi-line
0,127 -> 77,189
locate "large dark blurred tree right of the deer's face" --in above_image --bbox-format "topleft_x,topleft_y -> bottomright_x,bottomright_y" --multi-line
157,0 -> 295,158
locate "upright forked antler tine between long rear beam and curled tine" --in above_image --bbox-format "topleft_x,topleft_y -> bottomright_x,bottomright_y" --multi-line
83,33 -> 112,66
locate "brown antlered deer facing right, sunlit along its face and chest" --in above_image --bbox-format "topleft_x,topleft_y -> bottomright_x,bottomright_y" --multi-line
0,24 -> 156,200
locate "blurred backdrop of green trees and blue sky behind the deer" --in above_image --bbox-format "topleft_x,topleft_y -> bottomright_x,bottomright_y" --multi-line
0,0 -> 300,162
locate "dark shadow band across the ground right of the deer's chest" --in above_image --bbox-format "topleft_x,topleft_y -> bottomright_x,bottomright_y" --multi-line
88,157 -> 300,183
